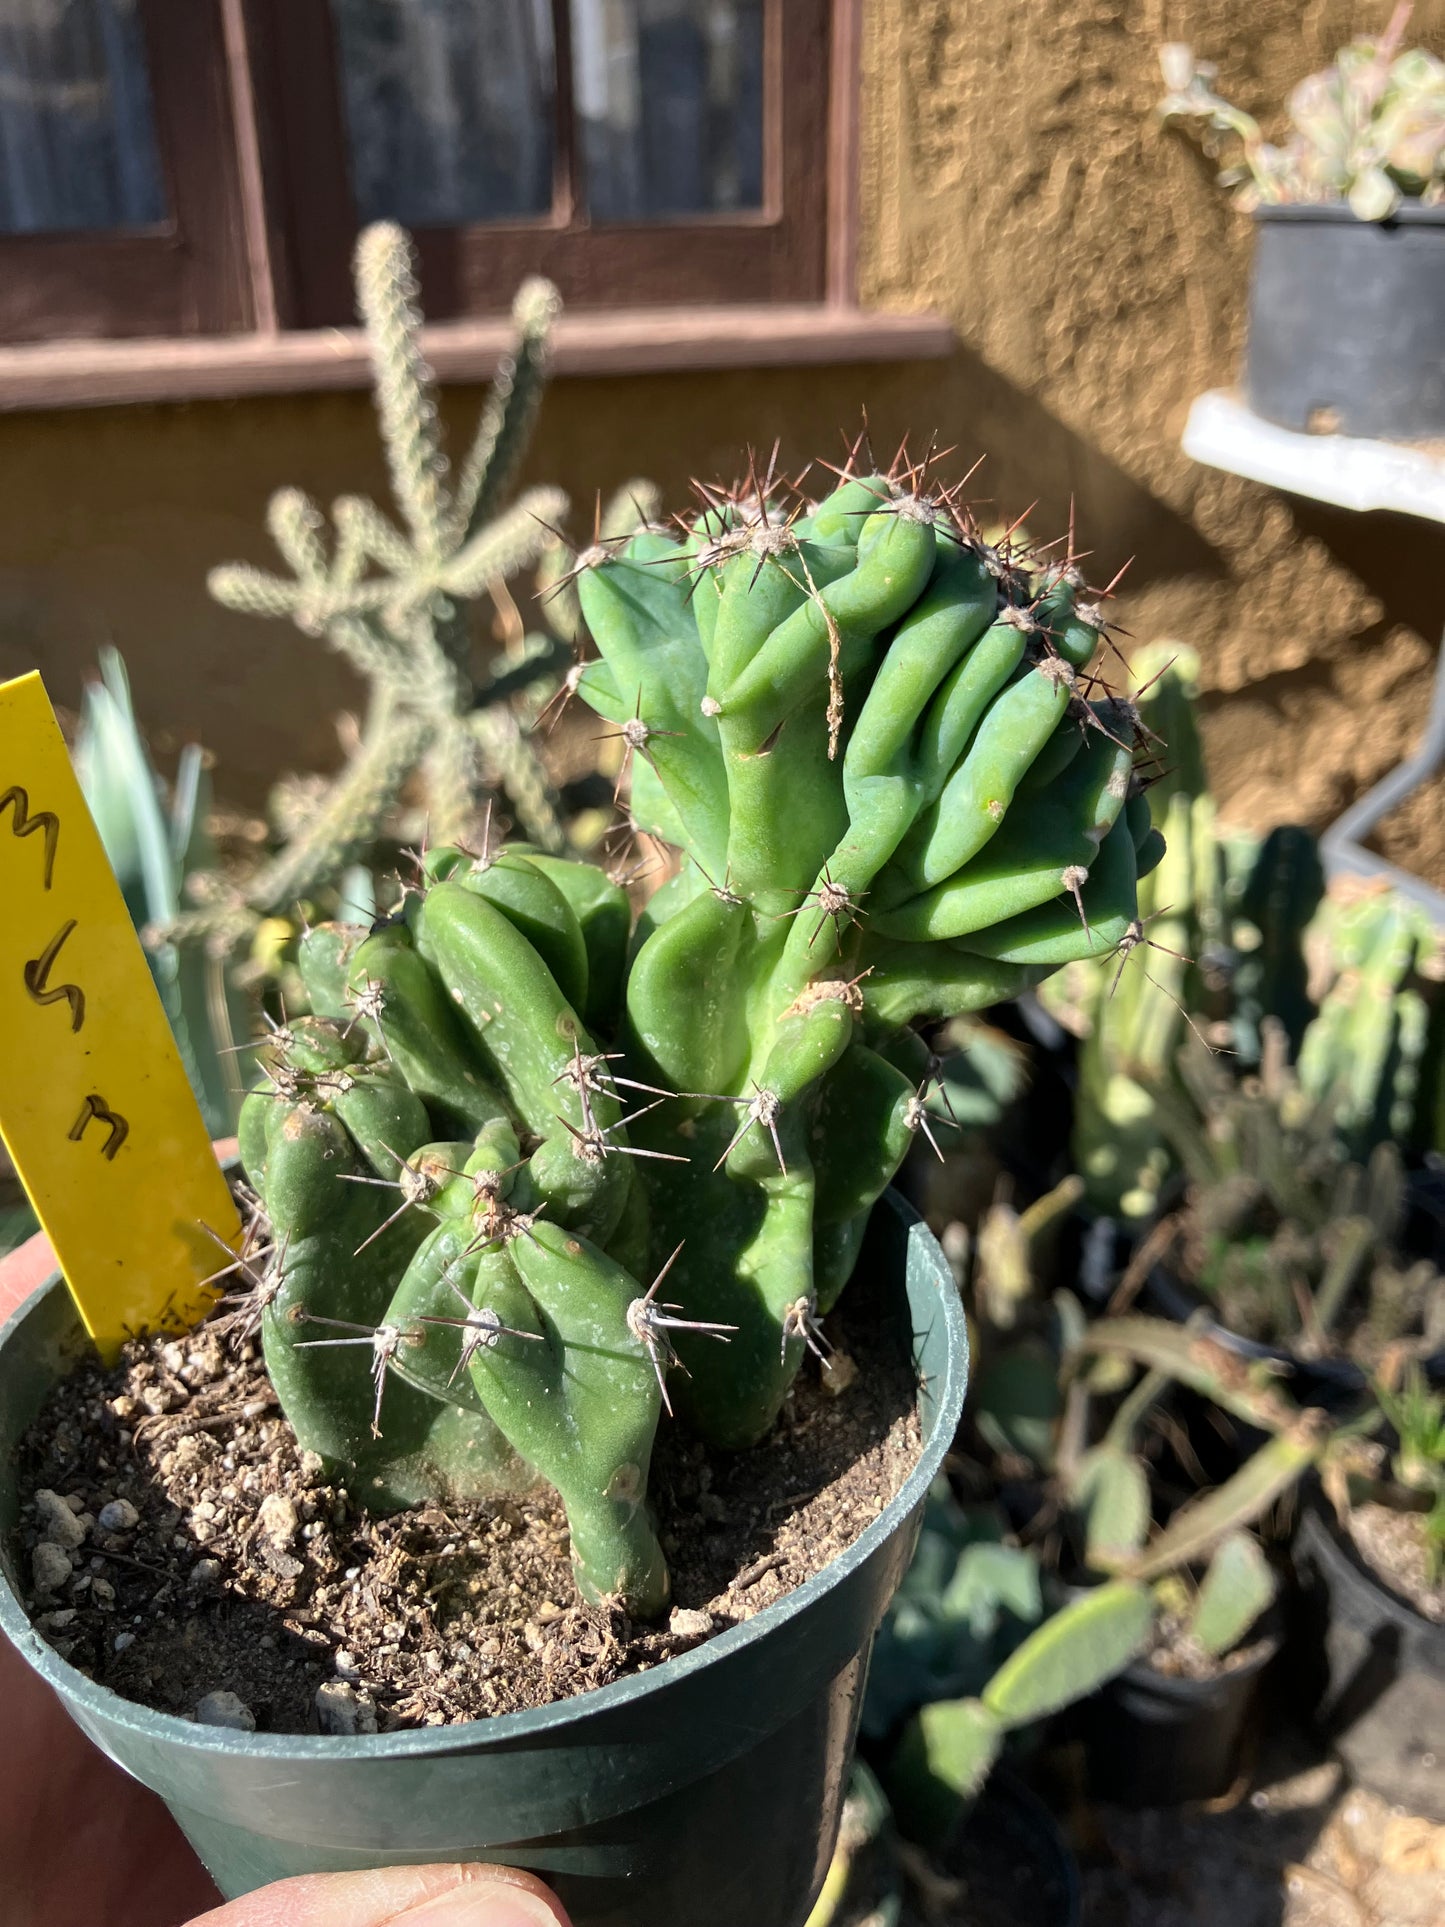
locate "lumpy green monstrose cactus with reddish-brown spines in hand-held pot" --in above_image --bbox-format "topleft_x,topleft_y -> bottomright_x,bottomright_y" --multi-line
235,443 -> 1162,1615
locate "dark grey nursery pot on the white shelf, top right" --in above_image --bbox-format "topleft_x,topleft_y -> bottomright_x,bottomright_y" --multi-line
1245,202 -> 1445,441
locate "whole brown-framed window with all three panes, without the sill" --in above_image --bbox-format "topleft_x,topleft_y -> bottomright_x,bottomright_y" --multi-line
0,0 -> 857,343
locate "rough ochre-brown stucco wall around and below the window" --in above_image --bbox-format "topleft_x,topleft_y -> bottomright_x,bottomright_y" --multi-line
0,0 -> 1445,821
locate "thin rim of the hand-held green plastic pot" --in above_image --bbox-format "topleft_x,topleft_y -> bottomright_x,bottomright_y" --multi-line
0,1189 -> 969,1763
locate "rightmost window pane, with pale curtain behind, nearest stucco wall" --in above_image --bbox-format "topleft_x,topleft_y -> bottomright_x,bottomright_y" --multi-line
572,0 -> 763,222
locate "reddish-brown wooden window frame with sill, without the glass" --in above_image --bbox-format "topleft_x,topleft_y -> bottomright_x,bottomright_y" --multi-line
0,0 -> 954,410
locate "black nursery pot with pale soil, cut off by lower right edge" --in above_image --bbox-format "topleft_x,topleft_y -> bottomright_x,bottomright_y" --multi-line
1293,1484 -> 1445,1821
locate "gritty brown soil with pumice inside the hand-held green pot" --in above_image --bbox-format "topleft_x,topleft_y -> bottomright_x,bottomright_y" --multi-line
13,1280 -> 919,1734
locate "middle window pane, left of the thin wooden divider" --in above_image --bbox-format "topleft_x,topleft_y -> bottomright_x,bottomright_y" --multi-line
331,0 -> 555,227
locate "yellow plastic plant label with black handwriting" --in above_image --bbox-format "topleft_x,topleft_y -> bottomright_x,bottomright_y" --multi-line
0,674 -> 239,1357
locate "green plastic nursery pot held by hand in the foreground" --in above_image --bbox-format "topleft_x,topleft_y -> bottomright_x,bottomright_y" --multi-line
0,1193 -> 967,1927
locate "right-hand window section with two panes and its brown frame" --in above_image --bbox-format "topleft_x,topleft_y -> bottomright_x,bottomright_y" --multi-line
270,0 -> 832,328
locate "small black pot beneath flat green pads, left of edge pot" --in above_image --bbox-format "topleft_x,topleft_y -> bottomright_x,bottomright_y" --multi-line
1073,1634 -> 1279,1808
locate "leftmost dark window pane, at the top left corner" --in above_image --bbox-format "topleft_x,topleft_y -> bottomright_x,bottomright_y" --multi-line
0,0 -> 168,235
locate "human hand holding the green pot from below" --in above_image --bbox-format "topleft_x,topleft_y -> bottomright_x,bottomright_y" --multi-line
0,1202 -> 568,1927
